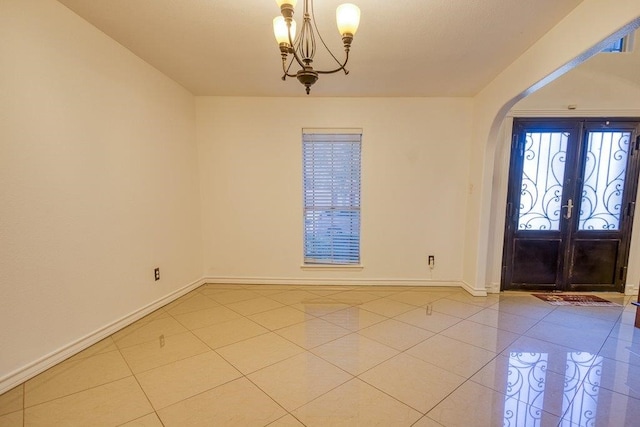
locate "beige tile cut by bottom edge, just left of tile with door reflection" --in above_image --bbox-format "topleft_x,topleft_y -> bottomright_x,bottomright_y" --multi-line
293,379 -> 422,427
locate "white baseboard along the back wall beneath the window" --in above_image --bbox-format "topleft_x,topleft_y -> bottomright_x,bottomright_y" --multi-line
203,276 -> 463,288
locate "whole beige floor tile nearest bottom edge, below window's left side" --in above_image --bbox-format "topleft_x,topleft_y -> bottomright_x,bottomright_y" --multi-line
248,352 -> 353,411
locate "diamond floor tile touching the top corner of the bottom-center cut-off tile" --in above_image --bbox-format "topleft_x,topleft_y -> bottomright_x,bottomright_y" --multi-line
312,334 -> 398,375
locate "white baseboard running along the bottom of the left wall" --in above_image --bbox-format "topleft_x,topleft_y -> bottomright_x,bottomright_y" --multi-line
0,279 -> 205,394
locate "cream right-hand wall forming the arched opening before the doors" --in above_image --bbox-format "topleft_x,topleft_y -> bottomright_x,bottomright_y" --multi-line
463,0 -> 640,292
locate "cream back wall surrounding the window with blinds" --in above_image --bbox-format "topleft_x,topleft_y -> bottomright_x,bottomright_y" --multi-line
196,98 -> 471,285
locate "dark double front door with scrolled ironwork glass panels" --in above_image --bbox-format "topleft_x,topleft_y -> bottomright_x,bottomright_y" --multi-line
501,119 -> 640,292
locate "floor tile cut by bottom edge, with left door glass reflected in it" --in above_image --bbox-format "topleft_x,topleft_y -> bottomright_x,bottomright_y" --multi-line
427,381 -> 560,427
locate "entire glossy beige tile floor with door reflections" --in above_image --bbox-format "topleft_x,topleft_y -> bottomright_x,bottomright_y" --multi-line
0,285 -> 640,427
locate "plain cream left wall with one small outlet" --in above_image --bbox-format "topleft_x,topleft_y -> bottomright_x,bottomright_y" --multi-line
0,0 -> 202,392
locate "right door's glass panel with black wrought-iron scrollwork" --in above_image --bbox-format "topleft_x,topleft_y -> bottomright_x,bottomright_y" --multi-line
578,131 -> 631,230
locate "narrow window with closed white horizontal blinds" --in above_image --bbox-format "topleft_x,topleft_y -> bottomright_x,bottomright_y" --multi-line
302,130 -> 362,265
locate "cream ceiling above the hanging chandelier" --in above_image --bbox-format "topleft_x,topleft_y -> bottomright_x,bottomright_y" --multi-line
59,0 -> 582,97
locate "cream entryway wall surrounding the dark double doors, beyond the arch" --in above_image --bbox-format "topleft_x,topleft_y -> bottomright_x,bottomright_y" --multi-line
489,45 -> 640,294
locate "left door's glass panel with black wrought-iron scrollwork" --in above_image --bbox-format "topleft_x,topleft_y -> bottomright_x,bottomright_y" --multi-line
518,132 -> 569,230
